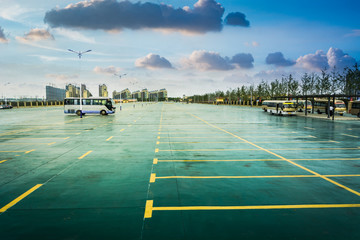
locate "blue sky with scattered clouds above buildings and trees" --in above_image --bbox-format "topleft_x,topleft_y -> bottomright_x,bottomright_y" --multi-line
0,0 -> 360,98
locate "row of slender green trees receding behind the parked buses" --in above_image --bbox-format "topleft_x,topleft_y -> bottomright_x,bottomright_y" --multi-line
190,64 -> 360,102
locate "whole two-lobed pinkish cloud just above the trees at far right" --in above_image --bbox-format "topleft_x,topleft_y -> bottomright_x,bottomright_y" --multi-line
296,47 -> 356,71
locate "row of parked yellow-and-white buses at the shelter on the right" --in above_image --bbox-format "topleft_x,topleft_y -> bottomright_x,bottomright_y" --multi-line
262,99 -> 360,118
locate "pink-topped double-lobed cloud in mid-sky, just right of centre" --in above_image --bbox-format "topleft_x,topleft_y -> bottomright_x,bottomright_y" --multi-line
183,50 -> 254,71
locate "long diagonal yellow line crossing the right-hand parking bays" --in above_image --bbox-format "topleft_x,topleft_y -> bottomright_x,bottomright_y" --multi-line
189,113 -> 360,196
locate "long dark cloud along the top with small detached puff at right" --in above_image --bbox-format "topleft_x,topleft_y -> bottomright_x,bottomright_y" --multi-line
44,0 -> 248,33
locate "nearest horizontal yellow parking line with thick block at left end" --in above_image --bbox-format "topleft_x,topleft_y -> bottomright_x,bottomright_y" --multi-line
144,200 -> 360,218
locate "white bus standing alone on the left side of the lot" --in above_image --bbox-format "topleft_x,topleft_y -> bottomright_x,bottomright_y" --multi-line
64,97 -> 115,116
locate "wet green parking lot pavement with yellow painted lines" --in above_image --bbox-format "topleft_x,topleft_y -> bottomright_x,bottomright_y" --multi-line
0,103 -> 360,239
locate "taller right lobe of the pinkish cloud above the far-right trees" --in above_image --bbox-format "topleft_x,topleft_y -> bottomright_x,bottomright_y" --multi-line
326,47 -> 356,70
